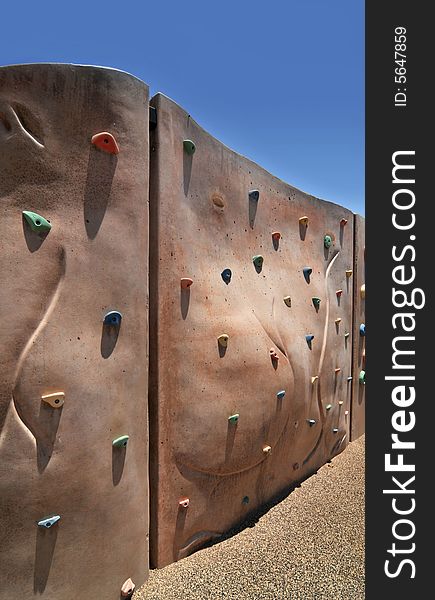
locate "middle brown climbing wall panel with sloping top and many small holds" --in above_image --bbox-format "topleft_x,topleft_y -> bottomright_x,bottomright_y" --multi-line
150,94 -> 353,566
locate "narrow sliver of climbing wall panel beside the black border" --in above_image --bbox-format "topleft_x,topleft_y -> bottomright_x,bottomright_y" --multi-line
351,215 -> 366,440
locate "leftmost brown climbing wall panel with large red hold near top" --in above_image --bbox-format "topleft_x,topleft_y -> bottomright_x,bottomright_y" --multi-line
0,64 -> 148,600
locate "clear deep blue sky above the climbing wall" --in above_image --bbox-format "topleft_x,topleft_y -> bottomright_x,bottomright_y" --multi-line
0,0 -> 364,214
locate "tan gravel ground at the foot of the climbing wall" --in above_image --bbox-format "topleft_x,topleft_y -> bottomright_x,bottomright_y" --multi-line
133,437 -> 364,600
